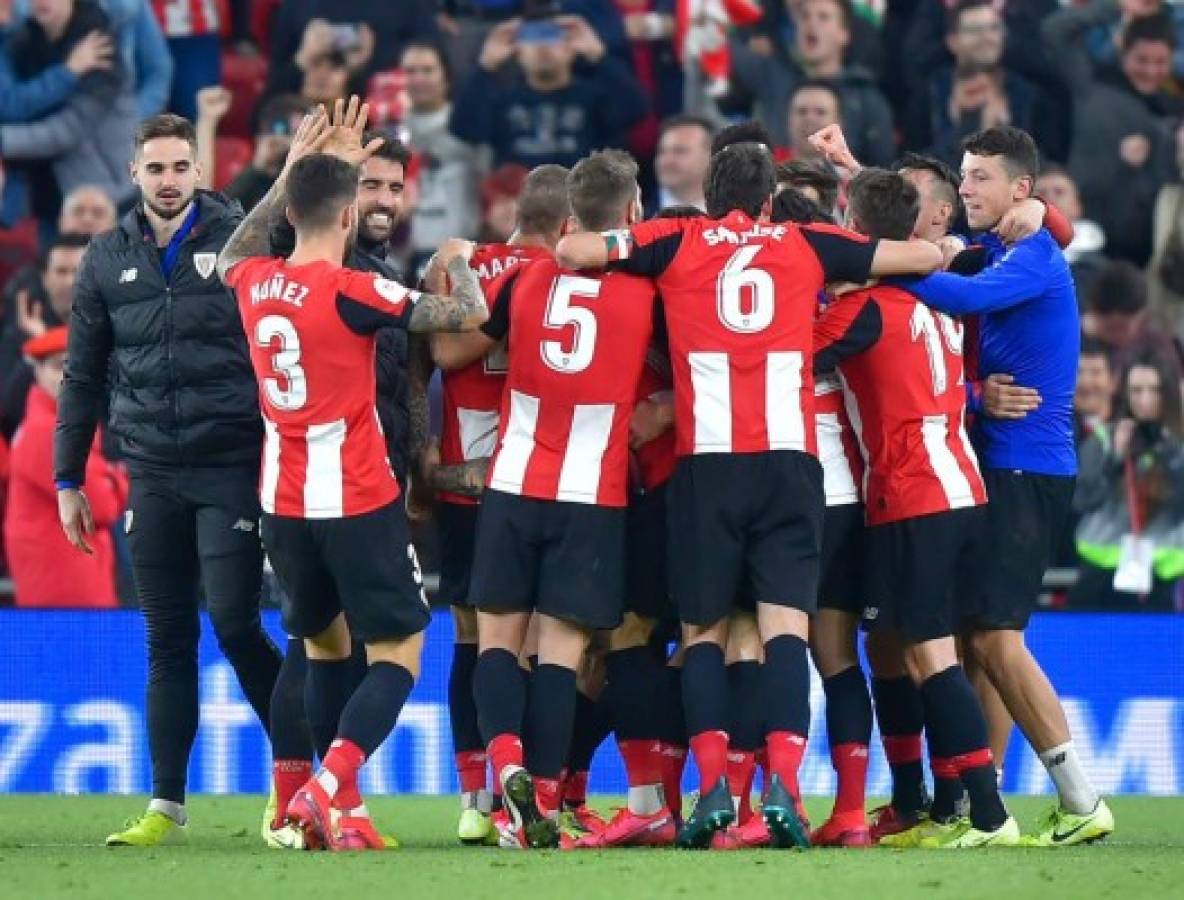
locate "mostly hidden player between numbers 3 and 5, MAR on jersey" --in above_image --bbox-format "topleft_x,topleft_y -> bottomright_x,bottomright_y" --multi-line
424,165 -> 571,844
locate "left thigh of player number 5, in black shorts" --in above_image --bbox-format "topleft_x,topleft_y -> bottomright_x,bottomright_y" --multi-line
469,490 -> 545,613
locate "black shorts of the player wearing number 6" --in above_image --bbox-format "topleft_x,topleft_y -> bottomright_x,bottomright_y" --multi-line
668,450 -> 825,625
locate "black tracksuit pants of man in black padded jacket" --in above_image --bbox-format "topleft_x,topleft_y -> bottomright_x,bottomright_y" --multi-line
126,463 -> 281,803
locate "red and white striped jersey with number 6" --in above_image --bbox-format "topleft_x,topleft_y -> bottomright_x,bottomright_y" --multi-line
605,212 -> 875,456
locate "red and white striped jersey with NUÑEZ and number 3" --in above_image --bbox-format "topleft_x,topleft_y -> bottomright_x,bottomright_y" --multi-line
226,257 -> 419,519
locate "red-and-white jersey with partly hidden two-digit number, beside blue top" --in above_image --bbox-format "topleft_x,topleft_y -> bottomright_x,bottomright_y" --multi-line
815,285 -> 986,525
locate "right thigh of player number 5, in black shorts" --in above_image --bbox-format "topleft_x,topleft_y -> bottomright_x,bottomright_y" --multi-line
535,502 -> 625,634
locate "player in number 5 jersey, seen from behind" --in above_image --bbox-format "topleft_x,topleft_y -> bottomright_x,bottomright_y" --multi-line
440,150 -> 654,847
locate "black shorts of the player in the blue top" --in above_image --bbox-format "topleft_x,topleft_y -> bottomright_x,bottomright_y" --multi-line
963,469 -> 1076,631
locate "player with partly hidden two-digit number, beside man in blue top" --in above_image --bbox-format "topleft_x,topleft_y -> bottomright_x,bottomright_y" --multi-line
815,169 -> 1019,848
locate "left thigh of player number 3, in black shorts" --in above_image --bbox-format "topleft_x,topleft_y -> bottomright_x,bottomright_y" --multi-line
259,513 -> 342,638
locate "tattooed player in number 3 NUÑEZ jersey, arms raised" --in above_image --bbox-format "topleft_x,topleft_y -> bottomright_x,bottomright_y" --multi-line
218,97 -> 488,850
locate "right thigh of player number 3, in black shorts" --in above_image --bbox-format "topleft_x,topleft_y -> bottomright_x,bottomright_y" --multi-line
316,500 -> 431,645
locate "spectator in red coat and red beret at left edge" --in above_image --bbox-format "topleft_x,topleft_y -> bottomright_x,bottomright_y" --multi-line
4,326 -> 128,609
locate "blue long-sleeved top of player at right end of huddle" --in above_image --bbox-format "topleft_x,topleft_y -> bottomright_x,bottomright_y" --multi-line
906,229 -> 1081,476
